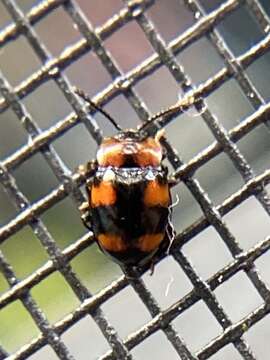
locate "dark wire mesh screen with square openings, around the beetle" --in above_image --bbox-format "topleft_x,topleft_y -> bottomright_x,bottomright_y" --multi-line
0,0 -> 270,360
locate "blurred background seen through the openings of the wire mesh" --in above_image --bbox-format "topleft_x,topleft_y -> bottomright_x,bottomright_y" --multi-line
0,0 -> 270,360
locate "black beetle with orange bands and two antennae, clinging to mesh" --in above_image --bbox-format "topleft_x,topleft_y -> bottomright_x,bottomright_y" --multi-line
75,89 -> 178,266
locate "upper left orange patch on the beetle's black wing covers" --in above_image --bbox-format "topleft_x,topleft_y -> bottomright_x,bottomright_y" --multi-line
91,181 -> 116,207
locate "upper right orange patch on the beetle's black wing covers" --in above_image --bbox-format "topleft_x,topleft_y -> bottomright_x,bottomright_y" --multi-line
143,180 -> 170,207
